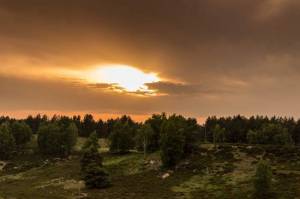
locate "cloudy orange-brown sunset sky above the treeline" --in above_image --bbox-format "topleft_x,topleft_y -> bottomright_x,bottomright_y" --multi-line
0,0 -> 300,119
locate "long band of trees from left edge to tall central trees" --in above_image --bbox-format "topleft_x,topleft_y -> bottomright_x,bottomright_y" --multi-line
0,113 -> 202,166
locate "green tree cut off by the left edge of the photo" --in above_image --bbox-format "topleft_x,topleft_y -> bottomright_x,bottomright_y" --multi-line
0,123 -> 15,159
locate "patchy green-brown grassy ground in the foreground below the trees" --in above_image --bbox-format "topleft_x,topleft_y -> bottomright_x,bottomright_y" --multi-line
0,140 -> 300,199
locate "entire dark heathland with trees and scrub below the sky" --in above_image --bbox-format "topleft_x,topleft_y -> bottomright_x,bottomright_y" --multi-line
0,113 -> 300,198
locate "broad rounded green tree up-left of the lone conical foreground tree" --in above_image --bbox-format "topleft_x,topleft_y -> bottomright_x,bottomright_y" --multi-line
38,122 -> 78,156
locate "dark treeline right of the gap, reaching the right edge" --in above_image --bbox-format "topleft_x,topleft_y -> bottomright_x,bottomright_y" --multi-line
203,115 -> 300,145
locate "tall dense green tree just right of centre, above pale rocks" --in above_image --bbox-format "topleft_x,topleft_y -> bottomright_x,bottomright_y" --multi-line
161,117 -> 185,168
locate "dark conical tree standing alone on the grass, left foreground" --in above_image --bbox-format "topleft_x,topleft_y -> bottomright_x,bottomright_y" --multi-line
80,132 -> 111,188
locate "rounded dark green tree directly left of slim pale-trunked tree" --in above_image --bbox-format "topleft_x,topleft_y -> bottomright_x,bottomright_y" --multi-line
109,120 -> 135,153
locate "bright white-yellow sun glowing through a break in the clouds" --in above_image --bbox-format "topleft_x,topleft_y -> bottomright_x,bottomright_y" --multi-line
87,65 -> 160,93
